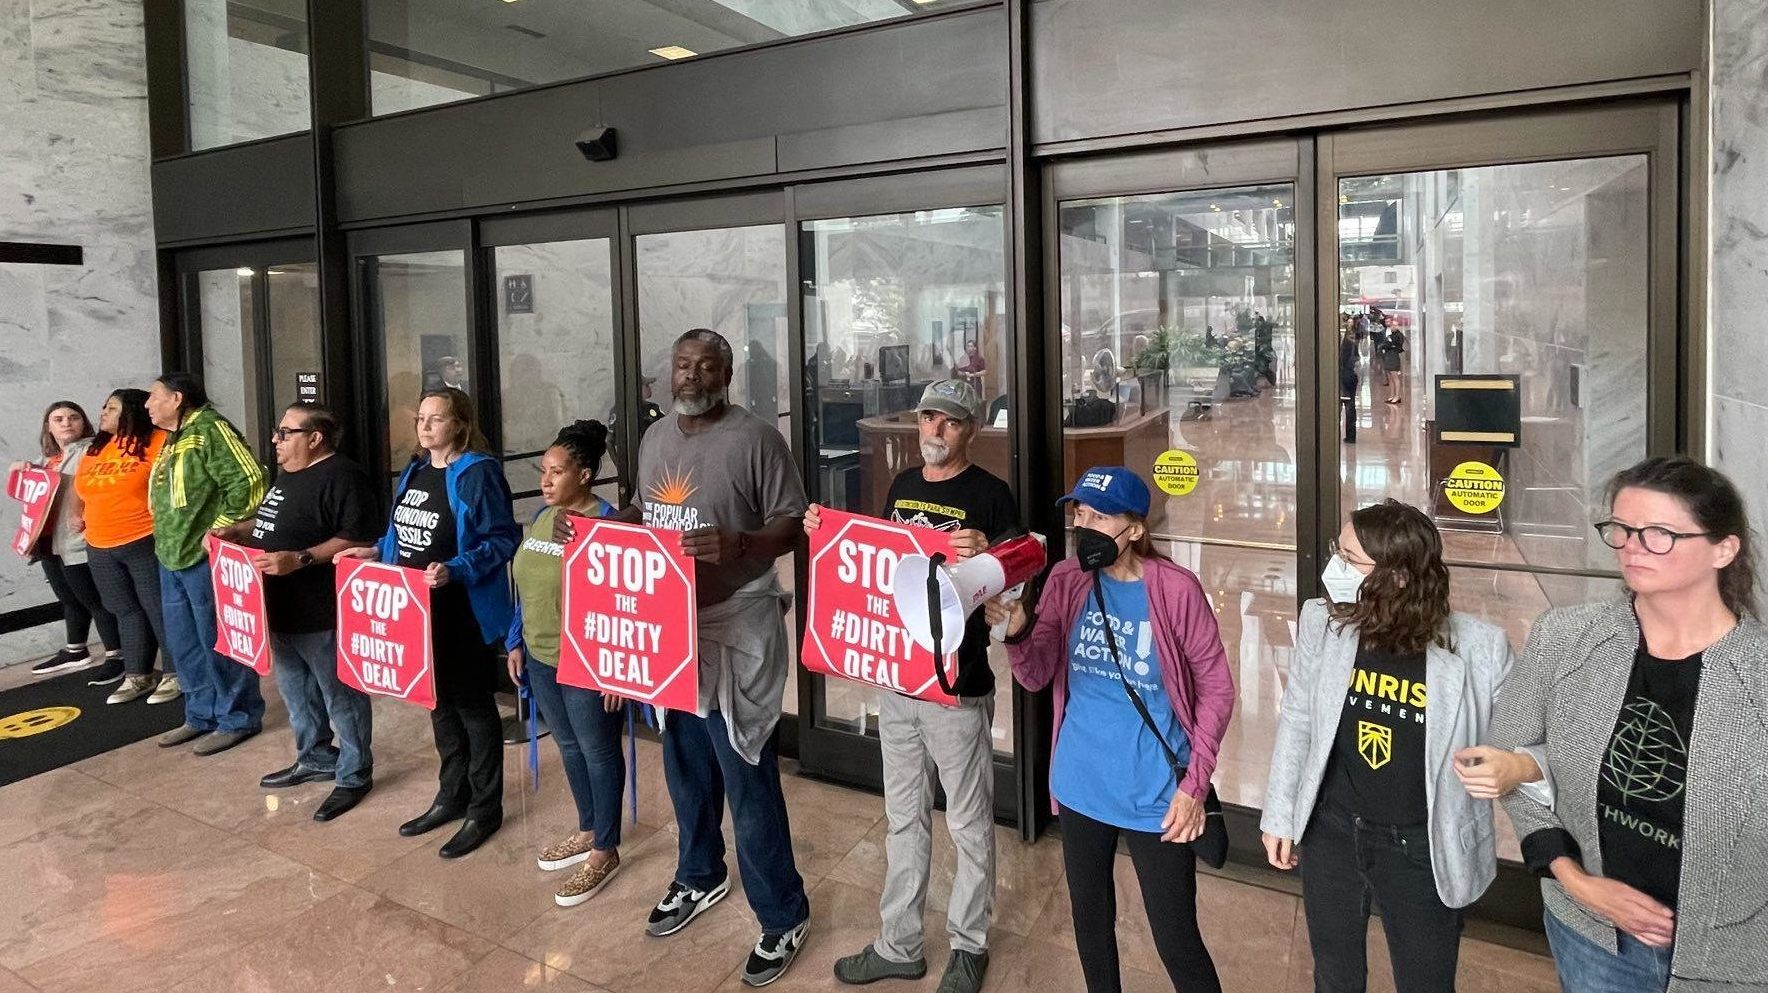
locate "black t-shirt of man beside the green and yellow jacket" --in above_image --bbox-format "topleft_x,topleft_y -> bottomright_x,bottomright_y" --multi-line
246,456 -> 380,634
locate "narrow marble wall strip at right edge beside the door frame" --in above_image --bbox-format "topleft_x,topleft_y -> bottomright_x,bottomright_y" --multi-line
1708,0 -> 1768,583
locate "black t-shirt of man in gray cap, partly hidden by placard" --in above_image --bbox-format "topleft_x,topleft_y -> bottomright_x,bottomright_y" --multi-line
884,465 -> 1018,696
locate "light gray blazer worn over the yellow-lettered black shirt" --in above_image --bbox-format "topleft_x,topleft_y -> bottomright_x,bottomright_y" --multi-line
1259,599 -> 1512,906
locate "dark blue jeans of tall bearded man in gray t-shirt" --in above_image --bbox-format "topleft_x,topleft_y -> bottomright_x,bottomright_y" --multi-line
663,710 -> 810,935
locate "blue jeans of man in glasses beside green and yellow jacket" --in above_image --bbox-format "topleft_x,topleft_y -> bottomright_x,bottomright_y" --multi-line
271,631 -> 375,790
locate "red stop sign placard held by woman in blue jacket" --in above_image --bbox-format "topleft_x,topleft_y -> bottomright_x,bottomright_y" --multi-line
338,558 -> 437,710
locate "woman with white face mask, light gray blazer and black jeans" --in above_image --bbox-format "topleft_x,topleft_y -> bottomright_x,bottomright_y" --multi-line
1259,500 -> 1512,993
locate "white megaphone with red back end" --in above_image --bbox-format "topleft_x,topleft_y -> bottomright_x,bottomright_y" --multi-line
891,534 -> 1043,667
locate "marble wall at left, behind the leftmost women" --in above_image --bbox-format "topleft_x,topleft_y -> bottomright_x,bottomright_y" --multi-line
0,0 -> 159,650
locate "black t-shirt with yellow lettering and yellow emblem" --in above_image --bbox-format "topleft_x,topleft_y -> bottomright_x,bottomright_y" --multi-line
1324,647 -> 1430,825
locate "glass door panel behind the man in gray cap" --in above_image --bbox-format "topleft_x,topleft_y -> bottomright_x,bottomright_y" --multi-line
799,207 -> 1013,753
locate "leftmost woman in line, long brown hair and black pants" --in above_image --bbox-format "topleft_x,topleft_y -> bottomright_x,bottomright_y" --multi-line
9,399 -> 124,686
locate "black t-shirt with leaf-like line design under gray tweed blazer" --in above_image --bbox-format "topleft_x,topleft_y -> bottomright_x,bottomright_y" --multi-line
1597,640 -> 1701,906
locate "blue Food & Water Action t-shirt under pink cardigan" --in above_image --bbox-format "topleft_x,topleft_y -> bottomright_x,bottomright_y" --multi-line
1050,576 -> 1192,834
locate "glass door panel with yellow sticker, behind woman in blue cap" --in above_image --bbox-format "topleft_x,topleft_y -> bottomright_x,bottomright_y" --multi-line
1052,184 -> 1307,807
